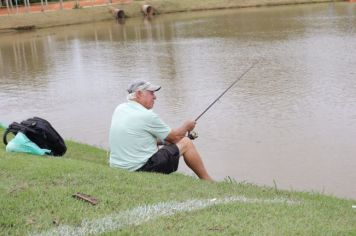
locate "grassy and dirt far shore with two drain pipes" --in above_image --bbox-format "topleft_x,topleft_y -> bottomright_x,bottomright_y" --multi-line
0,0 -> 344,33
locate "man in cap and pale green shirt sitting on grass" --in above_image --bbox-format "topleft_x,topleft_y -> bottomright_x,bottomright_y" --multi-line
109,81 -> 212,181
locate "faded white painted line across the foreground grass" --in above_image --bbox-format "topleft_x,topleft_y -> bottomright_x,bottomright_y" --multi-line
32,196 -> 298,236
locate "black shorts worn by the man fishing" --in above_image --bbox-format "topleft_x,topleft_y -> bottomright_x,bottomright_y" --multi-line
137,144 -> 179,174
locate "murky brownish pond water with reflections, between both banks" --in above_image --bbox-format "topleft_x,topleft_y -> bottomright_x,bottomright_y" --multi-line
0,3 -> 356,198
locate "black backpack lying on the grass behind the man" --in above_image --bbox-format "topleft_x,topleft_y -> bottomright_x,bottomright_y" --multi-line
3,117 -> 67,156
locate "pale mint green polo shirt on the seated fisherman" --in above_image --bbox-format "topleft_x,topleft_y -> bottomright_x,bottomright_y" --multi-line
109,101 -> 171,171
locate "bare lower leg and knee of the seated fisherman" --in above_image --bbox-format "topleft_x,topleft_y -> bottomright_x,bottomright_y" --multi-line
176,137 -> 213,181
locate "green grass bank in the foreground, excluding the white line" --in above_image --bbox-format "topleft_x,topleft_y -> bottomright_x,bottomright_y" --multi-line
0,129 -> 356,235
